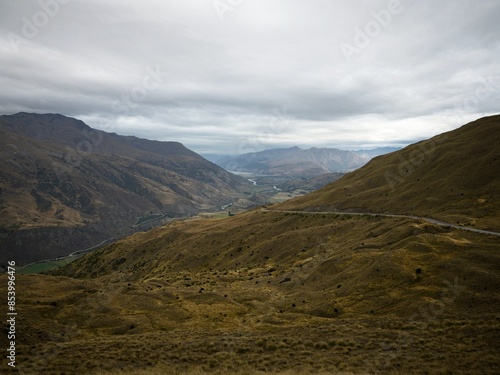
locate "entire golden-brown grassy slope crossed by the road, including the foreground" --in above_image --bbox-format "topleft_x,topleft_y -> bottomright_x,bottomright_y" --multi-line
11,116 -> 500,374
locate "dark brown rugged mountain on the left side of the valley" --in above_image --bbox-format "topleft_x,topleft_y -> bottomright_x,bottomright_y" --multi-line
0,113 -> 245,263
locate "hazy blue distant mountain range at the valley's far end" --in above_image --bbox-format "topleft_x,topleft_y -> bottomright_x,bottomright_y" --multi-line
216,146 -> 369,178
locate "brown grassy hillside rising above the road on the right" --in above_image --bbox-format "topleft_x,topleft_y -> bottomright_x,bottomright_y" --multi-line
282,115 -> 500,231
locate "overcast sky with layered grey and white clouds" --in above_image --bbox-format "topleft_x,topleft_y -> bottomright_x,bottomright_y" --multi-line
0,0 -> 500,154
